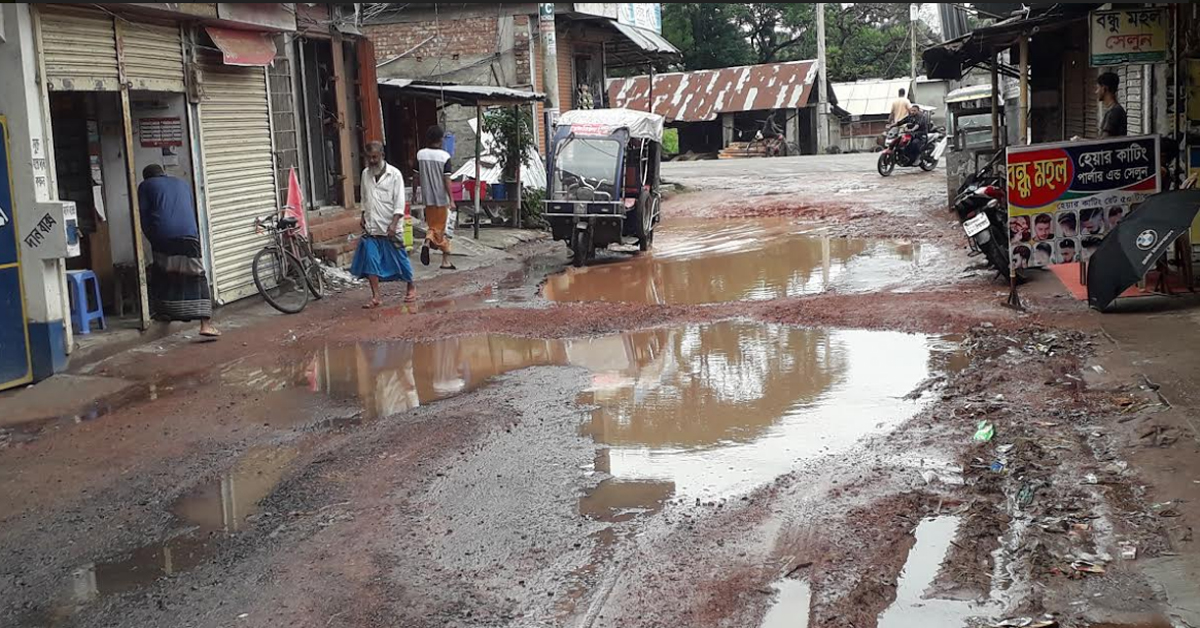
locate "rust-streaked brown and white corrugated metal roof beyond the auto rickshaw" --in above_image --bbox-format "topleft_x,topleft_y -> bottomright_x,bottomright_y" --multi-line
608,61 -> 817,122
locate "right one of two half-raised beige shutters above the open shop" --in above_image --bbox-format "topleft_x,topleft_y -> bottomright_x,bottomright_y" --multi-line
121,23 -> 184,91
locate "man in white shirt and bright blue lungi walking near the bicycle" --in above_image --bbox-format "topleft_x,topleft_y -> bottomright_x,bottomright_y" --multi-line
350,142 -> 416,310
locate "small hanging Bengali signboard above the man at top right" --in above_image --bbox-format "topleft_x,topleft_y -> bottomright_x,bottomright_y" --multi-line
1091,7 -> 1171,67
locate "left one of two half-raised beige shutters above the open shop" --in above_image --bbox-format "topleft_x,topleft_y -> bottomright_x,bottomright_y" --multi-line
38,5 -> 120,91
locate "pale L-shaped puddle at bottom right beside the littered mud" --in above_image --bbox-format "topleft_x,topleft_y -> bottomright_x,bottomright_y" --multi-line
878,516 -> 989,628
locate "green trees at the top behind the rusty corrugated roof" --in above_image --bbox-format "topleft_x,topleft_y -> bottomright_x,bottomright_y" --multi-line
662,2 -> 934,82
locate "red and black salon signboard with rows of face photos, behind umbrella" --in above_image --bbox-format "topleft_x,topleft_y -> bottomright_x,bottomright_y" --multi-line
1008,136 -> 1162,269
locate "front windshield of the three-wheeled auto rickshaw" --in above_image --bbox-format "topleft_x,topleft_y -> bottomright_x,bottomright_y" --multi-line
553,136 -> 620,201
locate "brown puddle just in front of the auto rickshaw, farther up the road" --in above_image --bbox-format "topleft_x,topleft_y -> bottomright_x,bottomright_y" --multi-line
544,221 -> 923,305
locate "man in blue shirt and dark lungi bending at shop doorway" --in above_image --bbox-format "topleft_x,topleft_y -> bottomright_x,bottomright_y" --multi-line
138,163 -> 221,339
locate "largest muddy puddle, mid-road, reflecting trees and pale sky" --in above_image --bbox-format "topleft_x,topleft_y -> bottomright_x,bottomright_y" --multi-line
296,322 -> 960,513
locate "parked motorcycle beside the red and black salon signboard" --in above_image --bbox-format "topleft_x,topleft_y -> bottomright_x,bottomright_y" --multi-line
953,151 -> 1010,277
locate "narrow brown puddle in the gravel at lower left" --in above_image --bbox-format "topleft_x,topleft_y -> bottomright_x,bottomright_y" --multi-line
59,448 -> 299,616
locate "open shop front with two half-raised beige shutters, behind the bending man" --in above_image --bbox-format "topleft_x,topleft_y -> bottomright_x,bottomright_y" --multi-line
35,5 -> 194,333
